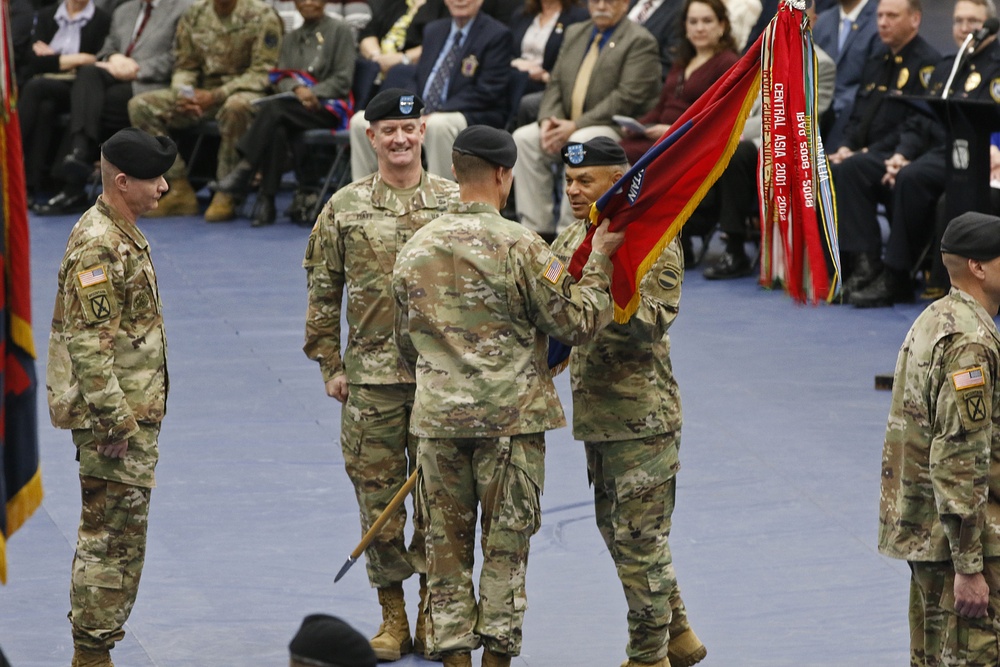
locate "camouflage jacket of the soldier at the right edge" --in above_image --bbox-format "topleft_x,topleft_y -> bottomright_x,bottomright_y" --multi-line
879,289 -> 1000,574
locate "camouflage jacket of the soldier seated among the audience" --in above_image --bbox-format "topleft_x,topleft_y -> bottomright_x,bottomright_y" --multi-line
170,0 -> 282,102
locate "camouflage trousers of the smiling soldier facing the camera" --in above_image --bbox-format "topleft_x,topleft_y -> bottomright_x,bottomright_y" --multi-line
340,384 -> 426,588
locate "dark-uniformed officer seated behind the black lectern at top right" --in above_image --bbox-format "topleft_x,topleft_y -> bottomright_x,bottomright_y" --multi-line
837,0 -> 1000,308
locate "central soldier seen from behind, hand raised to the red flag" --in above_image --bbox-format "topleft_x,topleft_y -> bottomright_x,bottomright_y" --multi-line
392,125 -> 622,667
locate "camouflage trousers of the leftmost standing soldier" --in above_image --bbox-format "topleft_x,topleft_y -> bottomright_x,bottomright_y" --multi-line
69,424 -> 160,651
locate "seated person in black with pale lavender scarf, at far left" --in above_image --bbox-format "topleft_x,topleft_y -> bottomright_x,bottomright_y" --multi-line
17,0 -> 111,202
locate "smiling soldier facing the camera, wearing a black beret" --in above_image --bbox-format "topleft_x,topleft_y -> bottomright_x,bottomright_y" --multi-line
303,88 -> 458,661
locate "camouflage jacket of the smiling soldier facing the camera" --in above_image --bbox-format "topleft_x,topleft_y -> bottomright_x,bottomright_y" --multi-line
302,172 -> 458,384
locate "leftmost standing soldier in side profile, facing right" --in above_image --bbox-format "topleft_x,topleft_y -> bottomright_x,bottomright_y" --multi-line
46,128 -> 177,667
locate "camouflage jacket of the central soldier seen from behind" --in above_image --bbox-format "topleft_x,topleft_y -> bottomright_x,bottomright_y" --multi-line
392,203 -> 613,438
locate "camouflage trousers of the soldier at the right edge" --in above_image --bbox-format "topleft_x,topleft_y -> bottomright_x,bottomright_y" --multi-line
910,558 -> 1000,667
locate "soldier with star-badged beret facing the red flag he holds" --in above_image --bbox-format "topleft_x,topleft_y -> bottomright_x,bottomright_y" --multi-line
552,137 -> 706,667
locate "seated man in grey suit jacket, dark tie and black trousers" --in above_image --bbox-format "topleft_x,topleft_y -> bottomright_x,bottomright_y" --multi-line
34,0 -> 193,215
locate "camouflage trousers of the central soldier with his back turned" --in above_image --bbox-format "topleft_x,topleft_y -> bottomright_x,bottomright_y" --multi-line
417,433 -> 545,656
